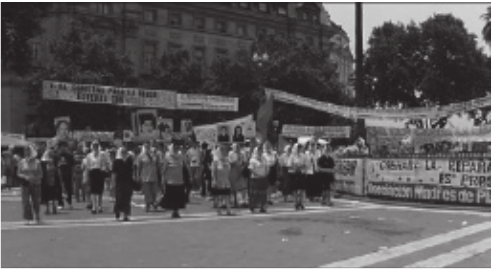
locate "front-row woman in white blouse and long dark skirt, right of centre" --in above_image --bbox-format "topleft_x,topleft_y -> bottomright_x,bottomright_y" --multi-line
248,145 -> 269,213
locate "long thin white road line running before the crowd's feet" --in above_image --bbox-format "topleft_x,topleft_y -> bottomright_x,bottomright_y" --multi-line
2,206 -> 374,231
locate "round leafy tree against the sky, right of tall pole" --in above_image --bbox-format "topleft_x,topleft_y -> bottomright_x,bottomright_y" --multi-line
365,15 -> 490,107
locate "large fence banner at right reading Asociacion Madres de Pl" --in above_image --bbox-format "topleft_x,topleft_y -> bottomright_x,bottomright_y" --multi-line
366,158 -> 491,205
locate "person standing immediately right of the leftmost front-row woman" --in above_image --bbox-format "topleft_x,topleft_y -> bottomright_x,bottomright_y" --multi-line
41,150 -> 60,215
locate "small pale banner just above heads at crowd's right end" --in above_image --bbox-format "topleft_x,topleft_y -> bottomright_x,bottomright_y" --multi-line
282,125 -> 351,139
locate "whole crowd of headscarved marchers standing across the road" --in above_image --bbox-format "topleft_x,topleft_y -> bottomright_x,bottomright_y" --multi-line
2,138 -> 335,224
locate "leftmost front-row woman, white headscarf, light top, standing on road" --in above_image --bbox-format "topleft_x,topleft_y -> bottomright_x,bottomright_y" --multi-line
17,146 -> 43,225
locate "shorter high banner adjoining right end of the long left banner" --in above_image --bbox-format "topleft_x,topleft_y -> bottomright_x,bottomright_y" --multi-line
176,94 -> 238,112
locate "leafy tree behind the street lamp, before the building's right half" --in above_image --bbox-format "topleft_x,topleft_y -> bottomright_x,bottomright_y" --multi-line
205,35 -> 351,125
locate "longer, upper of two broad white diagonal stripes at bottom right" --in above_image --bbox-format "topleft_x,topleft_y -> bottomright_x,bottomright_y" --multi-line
322,222 -> 491,268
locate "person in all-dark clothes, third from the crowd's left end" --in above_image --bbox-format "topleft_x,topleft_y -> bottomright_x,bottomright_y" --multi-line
55,142 -> 74,209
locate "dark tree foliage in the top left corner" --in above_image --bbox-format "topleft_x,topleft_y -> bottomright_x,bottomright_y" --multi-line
2,2 -> 52,75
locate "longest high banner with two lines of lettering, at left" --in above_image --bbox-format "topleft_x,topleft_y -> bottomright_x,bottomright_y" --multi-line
43,81 -> 176,109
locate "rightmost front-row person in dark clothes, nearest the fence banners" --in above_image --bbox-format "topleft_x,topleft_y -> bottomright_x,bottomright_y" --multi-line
317,145 -> 335,206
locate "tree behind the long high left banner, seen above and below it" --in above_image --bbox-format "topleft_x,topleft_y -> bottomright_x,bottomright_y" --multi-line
26,20 -> 138,134
